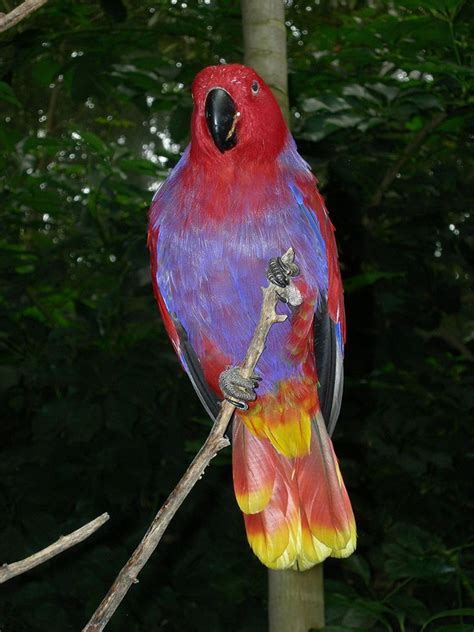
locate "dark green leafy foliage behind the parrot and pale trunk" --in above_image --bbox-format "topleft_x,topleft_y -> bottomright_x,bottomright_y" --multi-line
0,0 -> 474,632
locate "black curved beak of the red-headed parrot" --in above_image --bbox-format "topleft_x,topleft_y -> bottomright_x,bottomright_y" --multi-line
205,88 -> 238,154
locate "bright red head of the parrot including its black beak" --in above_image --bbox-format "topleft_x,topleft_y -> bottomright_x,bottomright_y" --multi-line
191,64 -> 288,162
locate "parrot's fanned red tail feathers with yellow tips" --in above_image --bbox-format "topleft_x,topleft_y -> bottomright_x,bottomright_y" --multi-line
233,412 -> 356,570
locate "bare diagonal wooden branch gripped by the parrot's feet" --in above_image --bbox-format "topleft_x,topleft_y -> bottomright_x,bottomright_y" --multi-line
82,248 -> 301,632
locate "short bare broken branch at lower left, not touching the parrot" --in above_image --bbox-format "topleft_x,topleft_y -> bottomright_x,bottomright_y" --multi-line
0,513 -> 109,584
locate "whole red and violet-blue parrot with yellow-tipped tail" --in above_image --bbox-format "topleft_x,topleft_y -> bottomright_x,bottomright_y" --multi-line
148,64 -> 356,571
